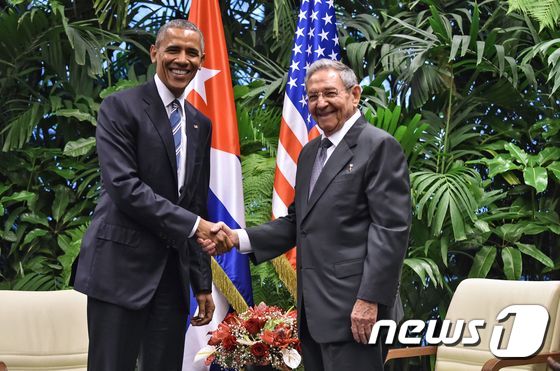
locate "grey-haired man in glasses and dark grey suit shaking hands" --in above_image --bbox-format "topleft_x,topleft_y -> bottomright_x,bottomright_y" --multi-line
199,59 -> 411,371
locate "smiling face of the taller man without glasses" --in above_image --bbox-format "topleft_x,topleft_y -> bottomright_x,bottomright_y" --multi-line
150,28 -> 204,97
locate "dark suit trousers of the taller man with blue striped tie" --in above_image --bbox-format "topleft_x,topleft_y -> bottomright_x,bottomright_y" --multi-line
87,249 -> 189,371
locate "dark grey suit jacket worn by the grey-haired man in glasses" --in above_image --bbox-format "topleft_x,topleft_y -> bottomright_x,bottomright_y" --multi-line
247,117 -> 411,343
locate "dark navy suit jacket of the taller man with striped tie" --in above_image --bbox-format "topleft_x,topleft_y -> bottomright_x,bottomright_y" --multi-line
74,81 -> 212,309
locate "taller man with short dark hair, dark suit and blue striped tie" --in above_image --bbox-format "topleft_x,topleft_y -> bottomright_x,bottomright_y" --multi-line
74,20 -> 227,371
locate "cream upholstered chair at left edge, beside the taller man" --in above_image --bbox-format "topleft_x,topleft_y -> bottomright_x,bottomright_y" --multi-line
0,290 -> 88,371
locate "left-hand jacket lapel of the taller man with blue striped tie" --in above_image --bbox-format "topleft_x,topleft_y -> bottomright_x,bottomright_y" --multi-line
144,80 -> 177,184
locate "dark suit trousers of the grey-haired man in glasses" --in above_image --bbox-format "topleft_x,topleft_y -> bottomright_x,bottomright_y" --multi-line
299,303 -> 388,371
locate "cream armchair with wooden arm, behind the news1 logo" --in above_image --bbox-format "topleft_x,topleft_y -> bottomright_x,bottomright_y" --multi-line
386,279 -> 560,371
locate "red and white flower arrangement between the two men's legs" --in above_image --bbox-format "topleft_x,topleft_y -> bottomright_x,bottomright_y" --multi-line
196,303 -> 301,370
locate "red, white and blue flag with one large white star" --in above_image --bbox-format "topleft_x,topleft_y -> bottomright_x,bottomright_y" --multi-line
183,0 -> 253,371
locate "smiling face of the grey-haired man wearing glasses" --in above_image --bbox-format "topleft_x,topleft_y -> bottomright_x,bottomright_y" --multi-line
306,69 -> 361,136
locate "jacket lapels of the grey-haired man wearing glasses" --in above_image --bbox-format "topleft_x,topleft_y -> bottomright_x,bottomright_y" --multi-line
301,116 -> 367,221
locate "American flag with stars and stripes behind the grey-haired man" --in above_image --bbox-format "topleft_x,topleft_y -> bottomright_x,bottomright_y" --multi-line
272,0 -> 340,266
